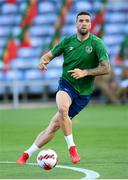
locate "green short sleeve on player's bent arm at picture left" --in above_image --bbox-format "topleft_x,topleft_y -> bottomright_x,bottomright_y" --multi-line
51,38 -> 65,57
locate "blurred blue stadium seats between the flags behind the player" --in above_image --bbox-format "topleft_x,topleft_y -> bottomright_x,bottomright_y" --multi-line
0,0 -> 128,102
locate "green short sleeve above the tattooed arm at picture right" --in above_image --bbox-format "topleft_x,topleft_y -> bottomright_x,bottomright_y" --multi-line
95,39 -> 109,61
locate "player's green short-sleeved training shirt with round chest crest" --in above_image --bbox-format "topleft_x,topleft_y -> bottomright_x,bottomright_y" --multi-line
51,34 -> 109,95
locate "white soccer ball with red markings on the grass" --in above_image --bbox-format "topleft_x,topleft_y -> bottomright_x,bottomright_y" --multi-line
37,149 -> 58,170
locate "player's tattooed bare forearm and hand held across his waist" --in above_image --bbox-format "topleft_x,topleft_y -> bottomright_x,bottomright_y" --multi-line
68,60 -> 111,79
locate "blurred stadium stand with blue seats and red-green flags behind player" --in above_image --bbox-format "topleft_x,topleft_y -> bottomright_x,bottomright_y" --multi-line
0,0 -> 128,108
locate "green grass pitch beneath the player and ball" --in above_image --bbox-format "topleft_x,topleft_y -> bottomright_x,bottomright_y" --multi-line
0,105 -> 128,179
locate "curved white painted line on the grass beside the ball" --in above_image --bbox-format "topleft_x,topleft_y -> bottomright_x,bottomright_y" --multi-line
0,161 -> 100,180
